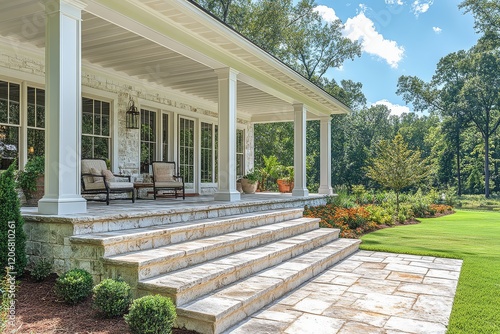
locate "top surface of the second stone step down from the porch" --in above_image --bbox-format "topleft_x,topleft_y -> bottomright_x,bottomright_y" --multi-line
103,218 -> 319,266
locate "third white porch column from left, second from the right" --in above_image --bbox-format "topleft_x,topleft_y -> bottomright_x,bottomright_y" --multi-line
292,104 -> 309,196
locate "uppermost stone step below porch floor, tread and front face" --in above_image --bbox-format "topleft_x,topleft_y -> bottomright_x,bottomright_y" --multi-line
70,208 -> 303,256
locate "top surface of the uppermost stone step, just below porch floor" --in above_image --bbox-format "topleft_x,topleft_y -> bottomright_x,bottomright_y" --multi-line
70,208 -> 303,245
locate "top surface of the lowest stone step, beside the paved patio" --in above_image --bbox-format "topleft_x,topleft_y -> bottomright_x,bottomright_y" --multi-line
177,239 -> 360,322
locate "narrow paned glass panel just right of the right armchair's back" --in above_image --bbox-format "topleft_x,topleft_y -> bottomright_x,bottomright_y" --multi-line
179,117 -> 194,183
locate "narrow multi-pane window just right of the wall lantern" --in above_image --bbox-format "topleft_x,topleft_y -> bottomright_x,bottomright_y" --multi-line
141,109 -> 156,173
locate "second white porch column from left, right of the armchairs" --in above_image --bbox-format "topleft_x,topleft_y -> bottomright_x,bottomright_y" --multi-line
214,68 -> 241,202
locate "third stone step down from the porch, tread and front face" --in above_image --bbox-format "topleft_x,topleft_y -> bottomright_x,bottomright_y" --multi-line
137,229 -> 339,305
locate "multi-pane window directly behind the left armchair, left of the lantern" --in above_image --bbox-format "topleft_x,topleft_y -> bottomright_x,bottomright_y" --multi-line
82,97 -> 111,159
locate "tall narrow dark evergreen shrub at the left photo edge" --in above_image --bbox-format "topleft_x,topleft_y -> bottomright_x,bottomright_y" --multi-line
0,163 -> 27,276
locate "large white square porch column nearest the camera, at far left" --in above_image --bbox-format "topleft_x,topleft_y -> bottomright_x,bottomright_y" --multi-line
38,0 -> 87,214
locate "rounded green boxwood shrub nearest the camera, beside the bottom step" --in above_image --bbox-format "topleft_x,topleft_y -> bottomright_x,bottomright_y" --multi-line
125,295 -> 177,334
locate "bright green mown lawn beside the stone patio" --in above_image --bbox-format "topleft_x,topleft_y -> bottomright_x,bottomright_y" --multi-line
360,210 -> 500,334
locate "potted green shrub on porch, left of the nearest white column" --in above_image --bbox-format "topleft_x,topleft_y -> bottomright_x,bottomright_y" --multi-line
17,156 -> 45,206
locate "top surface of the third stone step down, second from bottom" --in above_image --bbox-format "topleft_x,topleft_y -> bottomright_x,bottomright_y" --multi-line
139,229 -> 339,294
